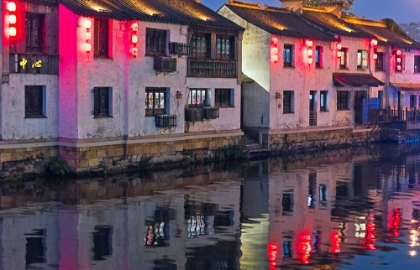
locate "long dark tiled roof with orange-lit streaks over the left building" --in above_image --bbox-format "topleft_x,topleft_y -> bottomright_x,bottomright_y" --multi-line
57,0 -> 243,31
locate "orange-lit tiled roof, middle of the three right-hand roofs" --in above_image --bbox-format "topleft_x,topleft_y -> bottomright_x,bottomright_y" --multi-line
302,10 -> 374,38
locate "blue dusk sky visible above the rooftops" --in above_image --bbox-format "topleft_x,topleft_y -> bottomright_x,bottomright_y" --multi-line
201,0 -> 420,23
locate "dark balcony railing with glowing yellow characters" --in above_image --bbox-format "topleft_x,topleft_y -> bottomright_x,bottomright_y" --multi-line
9,53 -> 59,74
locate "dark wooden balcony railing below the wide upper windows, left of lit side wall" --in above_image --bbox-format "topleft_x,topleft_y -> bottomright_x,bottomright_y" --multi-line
188,58 -> 237,78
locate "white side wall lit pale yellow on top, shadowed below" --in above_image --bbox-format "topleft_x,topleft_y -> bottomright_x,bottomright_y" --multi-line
218,6 -> 271,128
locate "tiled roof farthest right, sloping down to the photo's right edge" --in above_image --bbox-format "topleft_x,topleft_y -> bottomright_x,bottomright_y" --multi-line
350,24 -> 420,49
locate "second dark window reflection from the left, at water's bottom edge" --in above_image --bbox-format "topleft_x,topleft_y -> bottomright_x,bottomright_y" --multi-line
92,226 -> 112,261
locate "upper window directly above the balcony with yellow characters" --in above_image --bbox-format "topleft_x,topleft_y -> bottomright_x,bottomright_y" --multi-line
26,13 -> 44,52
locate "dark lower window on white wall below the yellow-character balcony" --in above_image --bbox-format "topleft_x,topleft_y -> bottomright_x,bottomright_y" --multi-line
25,85 -> 45,118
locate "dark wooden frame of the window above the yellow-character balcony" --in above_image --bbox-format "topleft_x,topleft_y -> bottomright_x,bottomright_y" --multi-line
25,12 -> 45,53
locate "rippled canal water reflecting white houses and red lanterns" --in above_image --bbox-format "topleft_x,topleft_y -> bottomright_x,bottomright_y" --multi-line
0,145 -> 420,270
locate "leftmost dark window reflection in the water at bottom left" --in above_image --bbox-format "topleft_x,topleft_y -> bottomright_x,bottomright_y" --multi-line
25,230 -> 46,266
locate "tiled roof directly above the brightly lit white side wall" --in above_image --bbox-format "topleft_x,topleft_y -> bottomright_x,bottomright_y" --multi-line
226,4 -> 335,41
